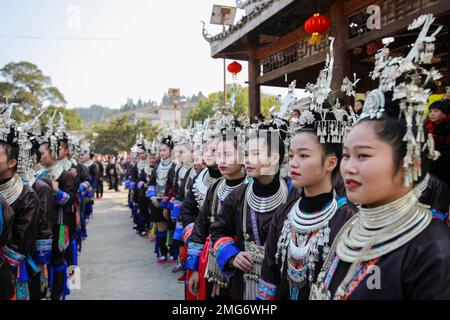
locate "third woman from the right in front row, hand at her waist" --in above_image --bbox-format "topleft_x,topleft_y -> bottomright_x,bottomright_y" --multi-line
210,119 -> 288,300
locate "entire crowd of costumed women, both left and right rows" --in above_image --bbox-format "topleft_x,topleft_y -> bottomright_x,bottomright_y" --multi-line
0,15 -> 450,300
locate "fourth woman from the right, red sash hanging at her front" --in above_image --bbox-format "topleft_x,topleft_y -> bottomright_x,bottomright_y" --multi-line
186,115 -> 248,300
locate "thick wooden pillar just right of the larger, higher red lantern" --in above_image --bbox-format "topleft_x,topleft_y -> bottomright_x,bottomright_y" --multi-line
330,0 -> 353,103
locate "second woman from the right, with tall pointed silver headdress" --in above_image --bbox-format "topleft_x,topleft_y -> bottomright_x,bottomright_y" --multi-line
257,39 -> 356,300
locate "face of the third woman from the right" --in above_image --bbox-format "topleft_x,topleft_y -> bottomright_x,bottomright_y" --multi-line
245,138 -> 279,178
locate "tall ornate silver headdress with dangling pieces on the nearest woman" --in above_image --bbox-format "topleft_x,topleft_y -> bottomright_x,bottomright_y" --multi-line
360,14 -> 442,186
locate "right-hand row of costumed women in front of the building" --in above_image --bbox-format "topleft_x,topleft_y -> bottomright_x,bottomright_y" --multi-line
125,15 -> 450,300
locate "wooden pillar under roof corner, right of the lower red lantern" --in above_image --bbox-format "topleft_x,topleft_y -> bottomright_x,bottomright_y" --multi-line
248,33 -> 261,119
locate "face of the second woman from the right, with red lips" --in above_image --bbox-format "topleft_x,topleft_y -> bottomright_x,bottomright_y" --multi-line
289,133 -> 338,188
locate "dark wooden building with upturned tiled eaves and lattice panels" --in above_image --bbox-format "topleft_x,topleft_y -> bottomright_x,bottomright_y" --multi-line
203,0 -> 450,115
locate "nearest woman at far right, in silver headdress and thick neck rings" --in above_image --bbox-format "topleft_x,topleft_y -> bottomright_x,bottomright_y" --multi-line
310,15 -> 450,300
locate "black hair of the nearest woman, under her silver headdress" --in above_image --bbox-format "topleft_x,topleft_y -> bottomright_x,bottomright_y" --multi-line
357,92 -> 430,186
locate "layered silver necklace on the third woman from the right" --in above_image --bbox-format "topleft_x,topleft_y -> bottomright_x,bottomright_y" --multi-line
246,179 -> 288,213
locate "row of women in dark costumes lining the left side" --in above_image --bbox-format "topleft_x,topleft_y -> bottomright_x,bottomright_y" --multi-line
0,109 -> 99,300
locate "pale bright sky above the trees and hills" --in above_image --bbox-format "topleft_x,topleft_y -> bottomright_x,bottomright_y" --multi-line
0,0 -> 298,108
